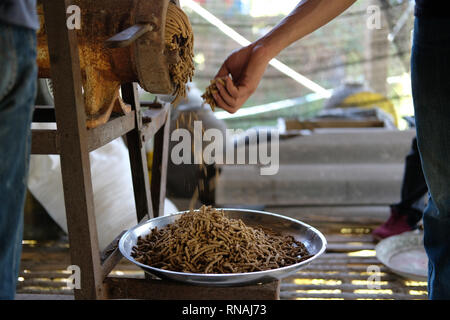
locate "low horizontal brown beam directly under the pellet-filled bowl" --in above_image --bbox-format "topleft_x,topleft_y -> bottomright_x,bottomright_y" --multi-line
105,277 -> 280,300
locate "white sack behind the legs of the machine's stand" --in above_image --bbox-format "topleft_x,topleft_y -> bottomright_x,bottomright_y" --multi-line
28,124 -> 178,250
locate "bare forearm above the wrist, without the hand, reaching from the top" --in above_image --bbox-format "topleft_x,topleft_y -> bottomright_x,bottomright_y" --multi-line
254,0 -> 356,60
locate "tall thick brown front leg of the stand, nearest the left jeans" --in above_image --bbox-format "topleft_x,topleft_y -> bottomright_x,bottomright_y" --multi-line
43,0 -> 103,299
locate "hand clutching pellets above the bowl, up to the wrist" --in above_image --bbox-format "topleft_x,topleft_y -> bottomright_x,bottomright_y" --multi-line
213,43 -> 270,113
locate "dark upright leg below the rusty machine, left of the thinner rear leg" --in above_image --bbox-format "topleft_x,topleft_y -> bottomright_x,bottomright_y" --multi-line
122,83 -> 153,222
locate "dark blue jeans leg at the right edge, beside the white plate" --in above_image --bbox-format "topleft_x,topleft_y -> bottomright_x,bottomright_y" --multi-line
411,18 -> 450,299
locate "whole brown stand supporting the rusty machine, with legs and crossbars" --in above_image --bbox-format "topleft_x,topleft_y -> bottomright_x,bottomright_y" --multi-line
32,0 -> 279,299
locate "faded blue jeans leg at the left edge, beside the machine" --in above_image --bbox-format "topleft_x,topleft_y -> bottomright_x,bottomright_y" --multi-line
0,23 -> 37,299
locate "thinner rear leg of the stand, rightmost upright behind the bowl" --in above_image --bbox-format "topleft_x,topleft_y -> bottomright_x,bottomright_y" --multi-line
150,104 -> 170,217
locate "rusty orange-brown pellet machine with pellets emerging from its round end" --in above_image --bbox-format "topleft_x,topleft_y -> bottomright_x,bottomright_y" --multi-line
33,0 -> 194,128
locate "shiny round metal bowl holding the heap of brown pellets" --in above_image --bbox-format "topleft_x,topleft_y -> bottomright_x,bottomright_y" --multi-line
119,209 -> 327,286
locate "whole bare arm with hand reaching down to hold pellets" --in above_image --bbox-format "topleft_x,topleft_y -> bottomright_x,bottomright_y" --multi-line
213,0 -> 356,113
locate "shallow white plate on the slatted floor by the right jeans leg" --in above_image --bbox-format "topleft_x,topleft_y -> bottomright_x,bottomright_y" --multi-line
375,231 -> 428,281
